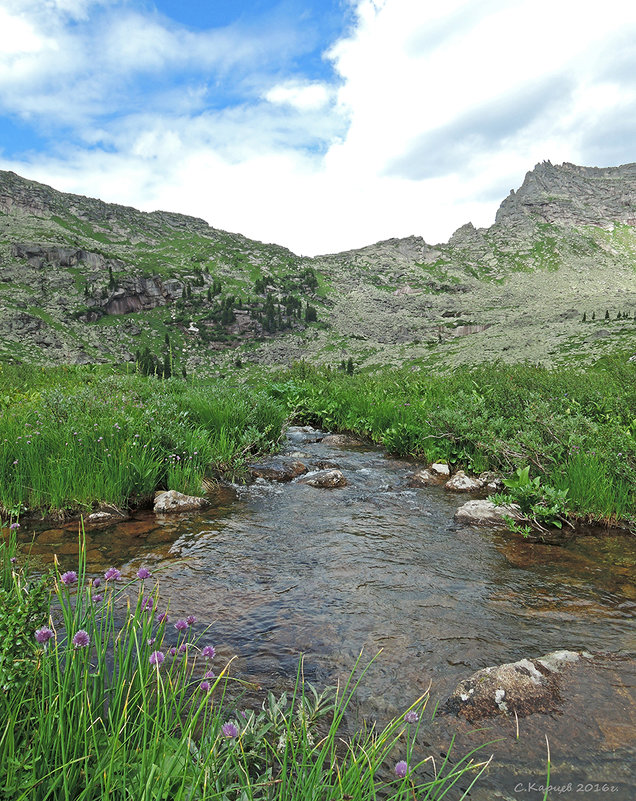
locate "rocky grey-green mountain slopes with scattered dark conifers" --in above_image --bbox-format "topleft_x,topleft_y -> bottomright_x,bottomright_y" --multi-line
0,162 -> 636,370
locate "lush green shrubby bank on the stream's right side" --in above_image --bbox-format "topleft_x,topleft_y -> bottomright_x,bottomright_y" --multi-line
270,358 -> 636,522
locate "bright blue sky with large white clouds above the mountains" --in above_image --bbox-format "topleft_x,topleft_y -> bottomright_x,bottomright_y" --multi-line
0,0 -> 636,255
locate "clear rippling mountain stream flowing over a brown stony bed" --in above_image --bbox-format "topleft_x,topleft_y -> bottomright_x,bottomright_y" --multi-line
21,429 -> 636,801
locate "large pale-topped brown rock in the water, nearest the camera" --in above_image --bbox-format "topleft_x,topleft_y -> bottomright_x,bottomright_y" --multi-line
443,651 -> 593,723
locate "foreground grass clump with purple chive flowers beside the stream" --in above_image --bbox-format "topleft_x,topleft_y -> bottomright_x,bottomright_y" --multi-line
0,527 -> 492,801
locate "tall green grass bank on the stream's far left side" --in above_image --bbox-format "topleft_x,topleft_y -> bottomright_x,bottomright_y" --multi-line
0,366 -> 287,514
